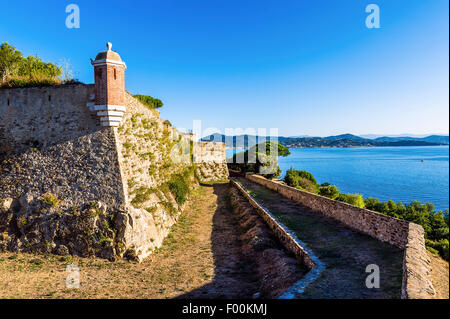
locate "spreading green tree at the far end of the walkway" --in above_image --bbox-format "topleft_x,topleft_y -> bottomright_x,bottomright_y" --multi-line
228,141 -> 291,178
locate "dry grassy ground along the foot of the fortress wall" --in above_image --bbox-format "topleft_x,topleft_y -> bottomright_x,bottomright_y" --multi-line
0,184 -> 301,298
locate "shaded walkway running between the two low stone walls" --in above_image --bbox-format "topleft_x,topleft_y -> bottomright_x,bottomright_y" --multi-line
237,178 -> 403,298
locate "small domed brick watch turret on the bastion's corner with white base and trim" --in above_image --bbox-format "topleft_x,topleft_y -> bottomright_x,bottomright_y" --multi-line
91,42 -> 127,126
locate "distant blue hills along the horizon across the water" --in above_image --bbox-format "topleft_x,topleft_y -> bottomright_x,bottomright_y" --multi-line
202,133 -> 449,148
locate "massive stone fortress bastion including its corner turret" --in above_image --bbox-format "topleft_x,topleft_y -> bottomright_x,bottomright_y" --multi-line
0,46 -> 228,260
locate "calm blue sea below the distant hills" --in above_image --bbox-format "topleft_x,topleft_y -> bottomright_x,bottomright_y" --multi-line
227,146 -> 449,209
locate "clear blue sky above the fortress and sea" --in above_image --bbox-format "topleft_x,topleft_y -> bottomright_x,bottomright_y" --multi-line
0,0 -> 449,136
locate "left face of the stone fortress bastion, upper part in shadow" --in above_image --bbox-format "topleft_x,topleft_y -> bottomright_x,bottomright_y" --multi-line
0,84 -> 125,258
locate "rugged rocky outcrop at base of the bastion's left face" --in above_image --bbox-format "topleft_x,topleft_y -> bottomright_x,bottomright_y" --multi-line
0,193 -> 117,260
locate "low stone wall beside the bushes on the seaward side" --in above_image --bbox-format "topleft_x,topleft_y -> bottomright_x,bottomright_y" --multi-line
245,174 -> 435,299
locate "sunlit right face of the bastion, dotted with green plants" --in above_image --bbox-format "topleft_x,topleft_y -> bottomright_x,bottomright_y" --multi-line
113,94 -> 194,261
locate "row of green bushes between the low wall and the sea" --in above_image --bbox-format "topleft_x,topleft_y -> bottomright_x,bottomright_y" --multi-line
284,168 -> 449,261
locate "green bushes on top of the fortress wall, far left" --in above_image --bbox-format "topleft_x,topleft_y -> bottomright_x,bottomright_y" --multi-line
0,42 -> 75,87
